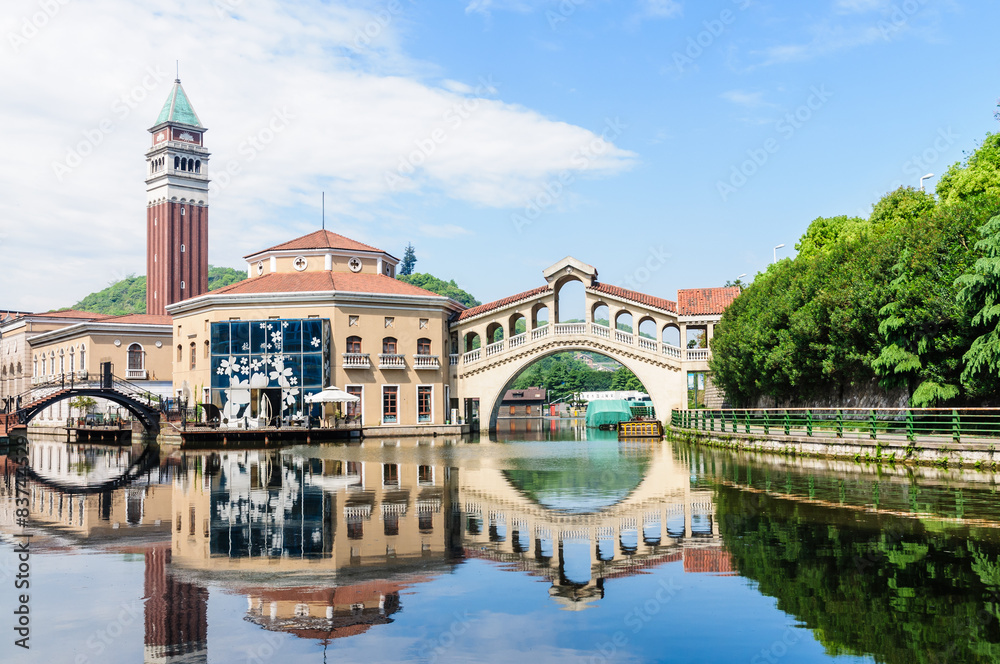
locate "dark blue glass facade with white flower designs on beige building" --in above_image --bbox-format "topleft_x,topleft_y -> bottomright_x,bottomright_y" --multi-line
211,318 -> 330,422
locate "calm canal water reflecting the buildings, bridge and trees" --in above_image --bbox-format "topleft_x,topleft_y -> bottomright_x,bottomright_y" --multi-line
0,420 -> 1000,664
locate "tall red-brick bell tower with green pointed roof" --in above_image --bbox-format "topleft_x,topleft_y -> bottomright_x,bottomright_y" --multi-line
146,79 -> 209,315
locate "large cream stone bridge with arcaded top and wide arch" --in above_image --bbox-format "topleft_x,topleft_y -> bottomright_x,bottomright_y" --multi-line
451,257 -> 739,430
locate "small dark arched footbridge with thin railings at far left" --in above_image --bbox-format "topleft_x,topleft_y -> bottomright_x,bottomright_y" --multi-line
0,364 -> 162,433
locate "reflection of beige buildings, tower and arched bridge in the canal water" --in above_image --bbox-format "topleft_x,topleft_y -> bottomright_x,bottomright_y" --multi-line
3,441 -> 732,662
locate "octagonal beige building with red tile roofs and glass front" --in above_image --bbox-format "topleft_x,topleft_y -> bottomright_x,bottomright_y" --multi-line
167,230 -> 464,427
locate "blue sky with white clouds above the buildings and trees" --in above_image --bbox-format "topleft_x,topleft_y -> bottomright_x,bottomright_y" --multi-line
0,0 -> 1000,311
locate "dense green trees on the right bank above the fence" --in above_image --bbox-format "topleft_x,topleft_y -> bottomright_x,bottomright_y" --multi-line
711,134 -> 1000,407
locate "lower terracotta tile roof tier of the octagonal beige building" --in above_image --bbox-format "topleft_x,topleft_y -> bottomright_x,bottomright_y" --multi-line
209,271 -> 442,297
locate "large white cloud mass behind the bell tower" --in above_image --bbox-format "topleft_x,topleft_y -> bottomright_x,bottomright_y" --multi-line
0,0 -> 635,309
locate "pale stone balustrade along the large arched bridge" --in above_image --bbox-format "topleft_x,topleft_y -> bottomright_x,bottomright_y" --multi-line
461,323 -> 709,364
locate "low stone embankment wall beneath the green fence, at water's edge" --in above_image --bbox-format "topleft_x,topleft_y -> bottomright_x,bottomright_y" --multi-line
667,425 -> 1000,469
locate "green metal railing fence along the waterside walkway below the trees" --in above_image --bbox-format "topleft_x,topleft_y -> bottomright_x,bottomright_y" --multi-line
670,408 -> 1000,443
